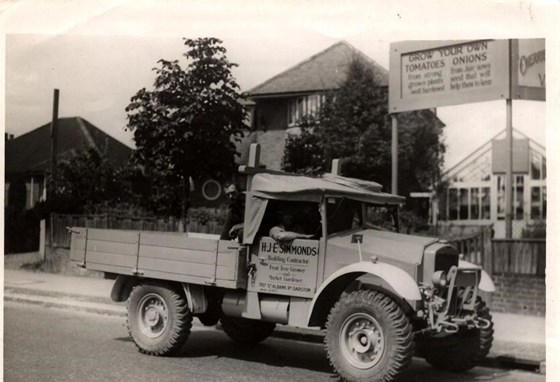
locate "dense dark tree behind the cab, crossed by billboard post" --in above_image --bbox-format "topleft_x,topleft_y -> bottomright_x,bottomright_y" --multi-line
283,57 -> 445,200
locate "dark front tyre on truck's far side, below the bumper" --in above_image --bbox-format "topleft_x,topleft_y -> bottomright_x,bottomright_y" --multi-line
418,298 -> 494,372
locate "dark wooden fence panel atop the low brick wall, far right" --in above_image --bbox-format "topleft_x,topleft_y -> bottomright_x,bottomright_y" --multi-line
492,239 -> 546,276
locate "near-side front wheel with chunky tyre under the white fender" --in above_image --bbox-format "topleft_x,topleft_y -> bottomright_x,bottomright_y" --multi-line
325,290 -> 414,382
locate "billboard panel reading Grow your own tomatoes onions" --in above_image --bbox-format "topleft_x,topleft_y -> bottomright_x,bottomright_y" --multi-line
389,40 -> 510,113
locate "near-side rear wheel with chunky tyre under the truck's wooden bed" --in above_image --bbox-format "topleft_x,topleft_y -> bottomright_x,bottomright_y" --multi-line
126,284 -> 192,356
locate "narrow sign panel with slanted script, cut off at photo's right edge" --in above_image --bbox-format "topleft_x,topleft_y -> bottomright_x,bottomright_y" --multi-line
511,38 -> 546,101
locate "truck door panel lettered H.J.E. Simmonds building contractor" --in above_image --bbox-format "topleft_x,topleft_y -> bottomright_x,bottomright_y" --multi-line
248,237 -> 319,297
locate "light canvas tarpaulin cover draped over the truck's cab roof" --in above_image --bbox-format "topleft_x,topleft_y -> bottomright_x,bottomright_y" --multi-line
243,174 -> 405,244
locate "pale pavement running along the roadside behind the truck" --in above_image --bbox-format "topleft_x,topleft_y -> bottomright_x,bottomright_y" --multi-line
4,269 -> 546,374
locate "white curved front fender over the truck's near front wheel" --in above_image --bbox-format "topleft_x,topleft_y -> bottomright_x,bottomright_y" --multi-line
308,261 -> 422,322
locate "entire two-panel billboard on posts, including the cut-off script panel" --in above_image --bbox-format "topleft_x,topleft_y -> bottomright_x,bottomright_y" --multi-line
389,38 -> 546,113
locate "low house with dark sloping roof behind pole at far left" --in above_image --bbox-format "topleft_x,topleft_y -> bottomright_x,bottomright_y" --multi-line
4,117 -> 132,209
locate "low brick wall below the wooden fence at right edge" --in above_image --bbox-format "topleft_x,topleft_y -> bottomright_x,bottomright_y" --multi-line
491,275 -> 546,316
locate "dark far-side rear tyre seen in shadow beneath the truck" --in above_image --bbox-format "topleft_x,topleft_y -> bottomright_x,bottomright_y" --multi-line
220,316 -> 276,344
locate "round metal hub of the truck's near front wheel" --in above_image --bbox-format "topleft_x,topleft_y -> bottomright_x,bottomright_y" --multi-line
340,313 -> 385,369
